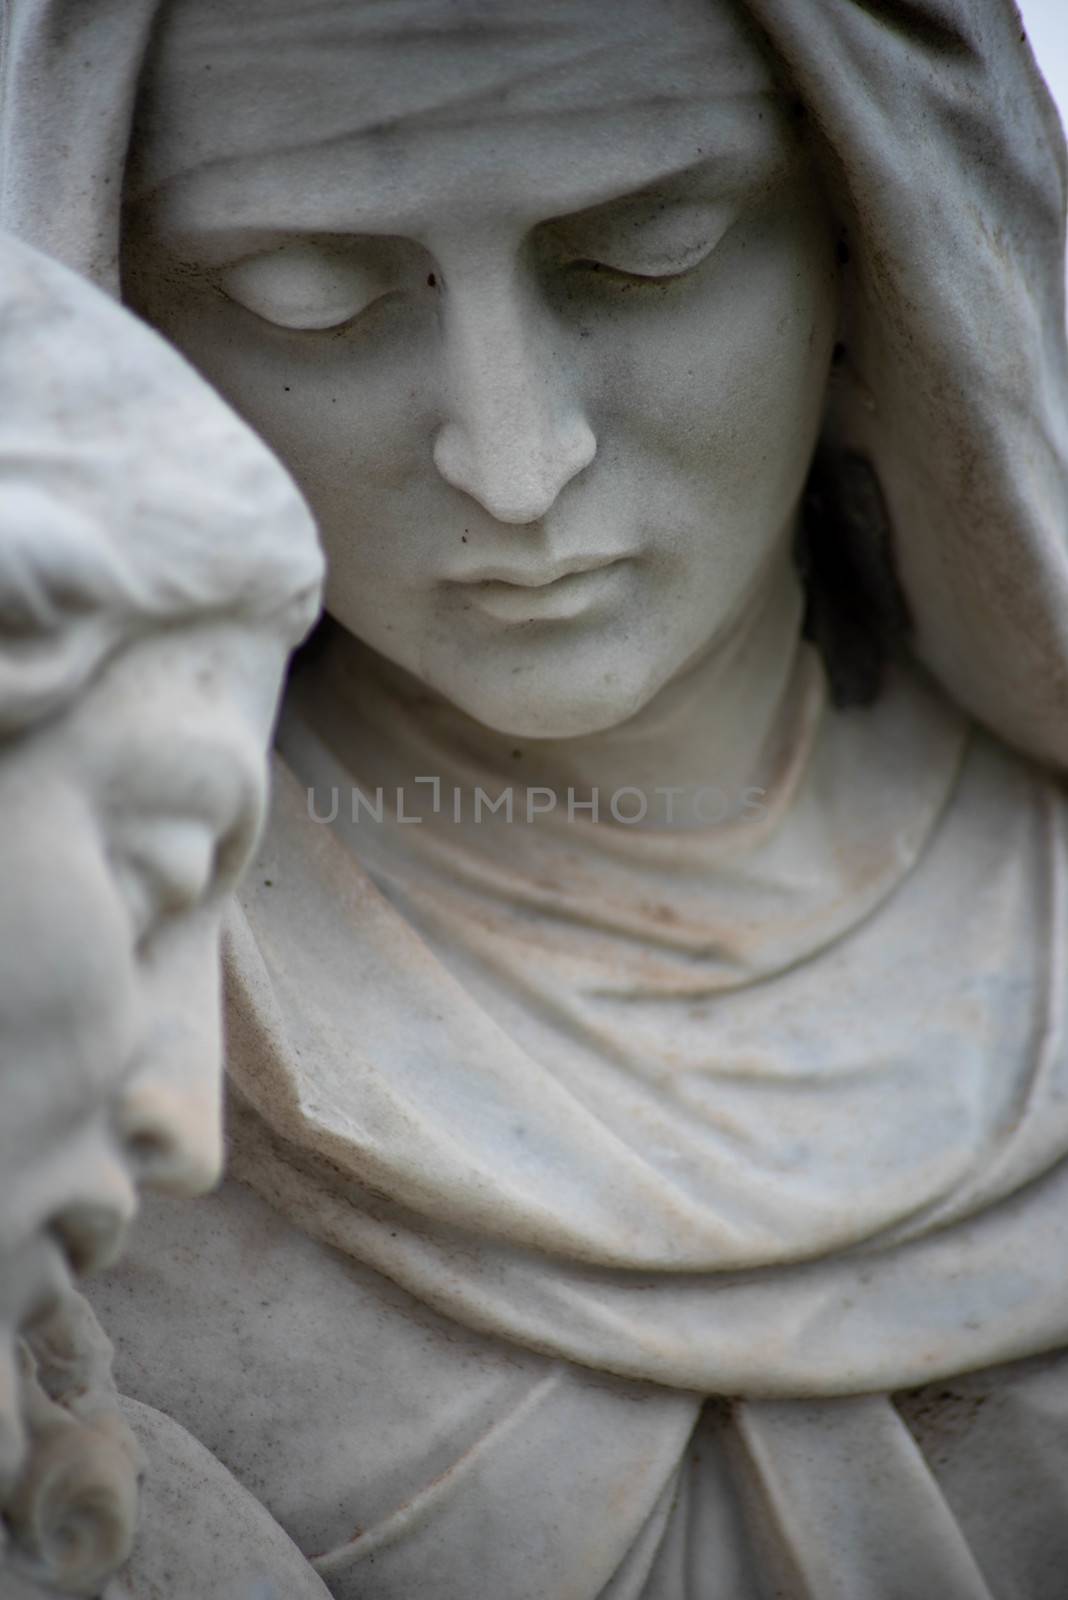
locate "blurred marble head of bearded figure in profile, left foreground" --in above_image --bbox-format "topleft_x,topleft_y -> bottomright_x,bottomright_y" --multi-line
0,238 -> 321,1600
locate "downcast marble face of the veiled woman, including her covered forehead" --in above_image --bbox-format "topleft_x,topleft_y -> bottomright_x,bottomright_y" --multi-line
126,0 -> 836,736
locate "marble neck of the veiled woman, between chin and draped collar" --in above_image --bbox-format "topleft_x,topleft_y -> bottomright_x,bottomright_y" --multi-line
322,557 -> 803,826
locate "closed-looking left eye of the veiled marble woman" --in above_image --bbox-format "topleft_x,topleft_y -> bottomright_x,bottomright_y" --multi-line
216,240 -> 393,331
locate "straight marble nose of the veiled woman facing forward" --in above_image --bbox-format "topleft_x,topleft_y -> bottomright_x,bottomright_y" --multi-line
433,254 -> 596,523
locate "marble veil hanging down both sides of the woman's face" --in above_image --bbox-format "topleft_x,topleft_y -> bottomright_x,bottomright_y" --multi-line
0,0 -> 1068,768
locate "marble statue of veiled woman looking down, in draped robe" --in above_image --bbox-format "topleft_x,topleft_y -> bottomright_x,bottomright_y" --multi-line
0,0 -> 1068,1600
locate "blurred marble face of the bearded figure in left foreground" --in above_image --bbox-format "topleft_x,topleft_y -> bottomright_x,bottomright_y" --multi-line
0,622 -> 285,1502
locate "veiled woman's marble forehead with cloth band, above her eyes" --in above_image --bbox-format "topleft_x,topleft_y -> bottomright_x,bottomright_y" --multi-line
128,0 -> 787,232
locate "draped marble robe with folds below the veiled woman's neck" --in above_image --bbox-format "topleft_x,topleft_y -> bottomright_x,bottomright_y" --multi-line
91,650 -> 1068,1600
